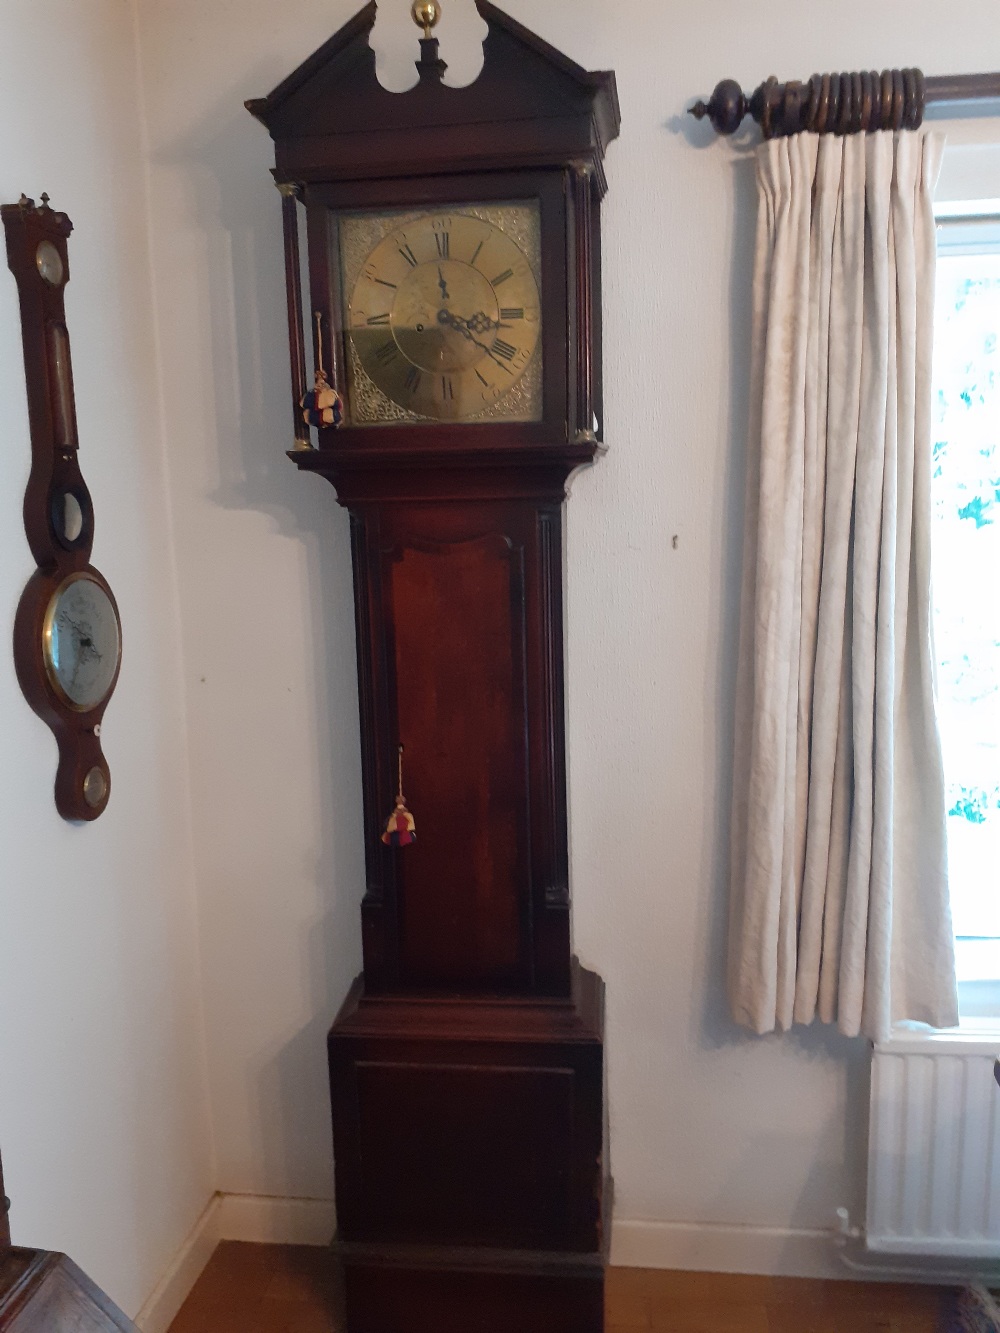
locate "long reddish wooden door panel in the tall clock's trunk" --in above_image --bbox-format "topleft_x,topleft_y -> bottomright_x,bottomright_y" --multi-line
383,511 -> 529,989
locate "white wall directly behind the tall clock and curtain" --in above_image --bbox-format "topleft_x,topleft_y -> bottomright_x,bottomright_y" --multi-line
131,0 -> 1000,1266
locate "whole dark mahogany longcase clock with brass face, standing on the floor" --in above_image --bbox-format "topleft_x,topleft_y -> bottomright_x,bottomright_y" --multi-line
248,0 -> 619,1333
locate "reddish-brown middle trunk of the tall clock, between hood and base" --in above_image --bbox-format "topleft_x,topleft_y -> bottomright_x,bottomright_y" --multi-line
355,501 -> 569,993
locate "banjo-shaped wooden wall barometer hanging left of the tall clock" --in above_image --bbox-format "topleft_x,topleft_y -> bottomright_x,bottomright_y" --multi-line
0,195 -> 121,820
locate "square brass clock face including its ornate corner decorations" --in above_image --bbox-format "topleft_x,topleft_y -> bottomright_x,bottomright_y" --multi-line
337,201 -> 543,425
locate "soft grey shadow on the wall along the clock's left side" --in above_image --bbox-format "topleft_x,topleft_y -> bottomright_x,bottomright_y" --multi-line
162,69 -> 364,1197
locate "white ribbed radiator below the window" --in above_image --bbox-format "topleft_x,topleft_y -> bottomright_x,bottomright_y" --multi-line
865,1033 -> 1000,1260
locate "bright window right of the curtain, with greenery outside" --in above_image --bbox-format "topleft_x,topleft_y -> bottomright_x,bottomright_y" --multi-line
932,200 -> 1000,1017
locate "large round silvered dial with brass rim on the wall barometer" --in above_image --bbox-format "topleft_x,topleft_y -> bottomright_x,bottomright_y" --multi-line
41,572 -> 121,713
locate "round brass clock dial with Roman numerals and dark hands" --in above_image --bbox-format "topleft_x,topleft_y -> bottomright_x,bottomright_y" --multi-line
349,213 -> 541,421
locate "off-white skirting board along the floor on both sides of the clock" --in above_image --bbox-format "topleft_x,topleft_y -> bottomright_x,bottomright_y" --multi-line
135,1194 -> 851,1333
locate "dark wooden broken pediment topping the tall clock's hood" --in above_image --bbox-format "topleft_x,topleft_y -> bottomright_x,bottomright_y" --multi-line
247,0 -> 620,192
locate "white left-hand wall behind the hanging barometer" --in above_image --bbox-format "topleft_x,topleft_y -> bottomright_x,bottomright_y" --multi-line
0,0 -> 213,1312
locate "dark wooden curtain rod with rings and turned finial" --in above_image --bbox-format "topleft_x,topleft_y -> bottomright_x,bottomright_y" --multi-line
689,69 -> 1000,139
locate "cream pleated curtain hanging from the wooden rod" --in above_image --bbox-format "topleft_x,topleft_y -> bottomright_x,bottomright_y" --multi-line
729,132 -> 959,1040
